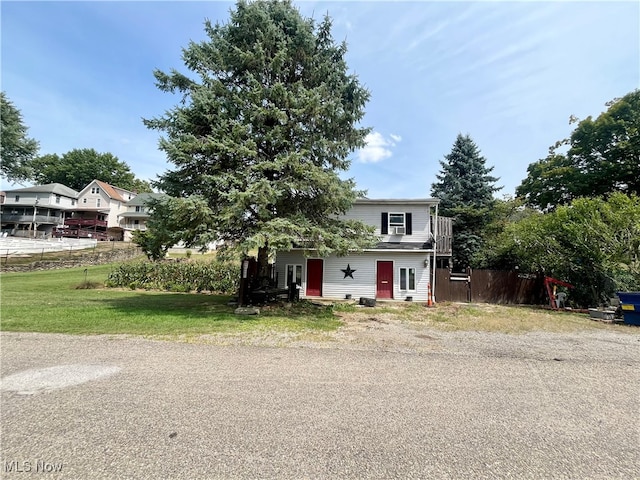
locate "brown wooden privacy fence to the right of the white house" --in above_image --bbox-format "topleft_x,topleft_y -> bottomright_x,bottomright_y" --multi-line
435,268 -> 547,305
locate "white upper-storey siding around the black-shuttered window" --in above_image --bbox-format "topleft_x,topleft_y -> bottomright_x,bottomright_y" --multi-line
342,204 -> 431,243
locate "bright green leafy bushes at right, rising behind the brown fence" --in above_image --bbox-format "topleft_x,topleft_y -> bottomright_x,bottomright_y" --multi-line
477,193 -> 640,307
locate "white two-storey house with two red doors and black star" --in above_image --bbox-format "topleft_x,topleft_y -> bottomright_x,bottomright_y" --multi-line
275,198 -> 451,301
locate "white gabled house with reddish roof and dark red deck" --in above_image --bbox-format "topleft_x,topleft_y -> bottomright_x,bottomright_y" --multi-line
58,180 -> 136,240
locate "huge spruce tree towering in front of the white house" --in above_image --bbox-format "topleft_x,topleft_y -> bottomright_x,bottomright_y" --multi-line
145,0 -> 371,274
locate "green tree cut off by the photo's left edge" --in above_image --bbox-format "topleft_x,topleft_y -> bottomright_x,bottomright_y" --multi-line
0,92 -> 38,182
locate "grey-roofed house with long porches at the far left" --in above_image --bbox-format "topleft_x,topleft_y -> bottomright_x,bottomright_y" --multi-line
1,183 -> 78,238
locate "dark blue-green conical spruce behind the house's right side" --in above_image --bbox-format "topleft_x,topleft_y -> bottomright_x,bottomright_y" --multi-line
431,134 -> 500,270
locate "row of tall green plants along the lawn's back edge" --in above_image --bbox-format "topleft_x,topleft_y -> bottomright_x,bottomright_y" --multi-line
106,261 -> 240,295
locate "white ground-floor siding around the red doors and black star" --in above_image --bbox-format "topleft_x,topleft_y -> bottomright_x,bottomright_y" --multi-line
276,251 -> 430,301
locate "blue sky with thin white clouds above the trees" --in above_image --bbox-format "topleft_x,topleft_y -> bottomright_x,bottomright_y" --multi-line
0,0 -> 640,198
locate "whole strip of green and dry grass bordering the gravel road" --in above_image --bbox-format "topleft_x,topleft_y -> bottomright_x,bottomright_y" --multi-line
0,265 -> 640,340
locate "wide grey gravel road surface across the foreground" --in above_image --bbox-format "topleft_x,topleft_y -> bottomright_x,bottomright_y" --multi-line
0,328 -> 640,479
